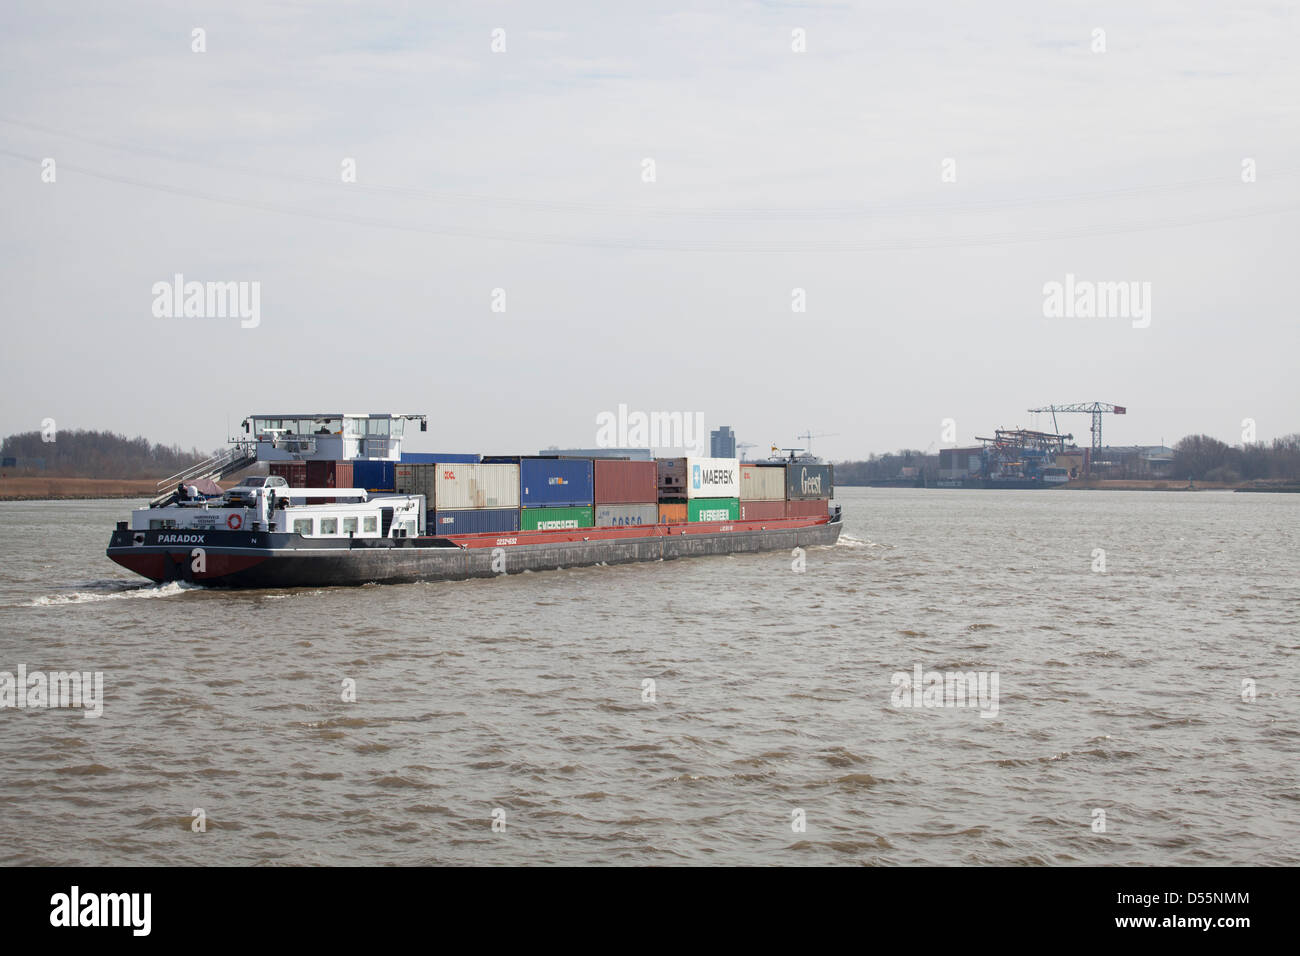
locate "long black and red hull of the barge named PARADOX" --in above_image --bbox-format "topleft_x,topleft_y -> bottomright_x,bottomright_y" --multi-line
108,514 -> 842,588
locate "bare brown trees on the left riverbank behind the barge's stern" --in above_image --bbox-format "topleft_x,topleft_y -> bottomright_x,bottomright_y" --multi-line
0,429 -> 211,479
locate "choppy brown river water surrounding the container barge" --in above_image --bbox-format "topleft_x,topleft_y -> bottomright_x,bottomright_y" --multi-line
0,488 -> 1300,865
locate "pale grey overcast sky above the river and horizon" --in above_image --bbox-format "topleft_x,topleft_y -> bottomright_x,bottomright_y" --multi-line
0,0 -> 1300,459
